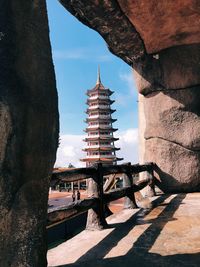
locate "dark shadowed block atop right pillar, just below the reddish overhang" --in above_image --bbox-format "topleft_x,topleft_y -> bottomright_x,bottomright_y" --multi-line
135,44 -> 200,95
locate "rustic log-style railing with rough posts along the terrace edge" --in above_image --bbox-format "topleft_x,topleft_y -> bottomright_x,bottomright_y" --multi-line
47,163 -> 155,230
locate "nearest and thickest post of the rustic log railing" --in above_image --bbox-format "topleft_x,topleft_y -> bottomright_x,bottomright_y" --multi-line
86,163 -> 107,231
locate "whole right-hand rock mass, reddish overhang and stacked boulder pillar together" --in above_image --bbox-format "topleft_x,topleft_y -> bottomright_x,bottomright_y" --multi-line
60,0 -> 200,192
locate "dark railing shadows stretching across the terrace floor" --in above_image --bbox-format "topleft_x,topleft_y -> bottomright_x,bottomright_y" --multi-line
51,194 -> 200,267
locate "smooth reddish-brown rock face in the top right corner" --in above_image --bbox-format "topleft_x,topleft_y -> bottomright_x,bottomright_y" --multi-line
118,0 -> 200,53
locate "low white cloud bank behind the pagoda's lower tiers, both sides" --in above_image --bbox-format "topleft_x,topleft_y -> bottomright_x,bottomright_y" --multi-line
55,129 -> 138,167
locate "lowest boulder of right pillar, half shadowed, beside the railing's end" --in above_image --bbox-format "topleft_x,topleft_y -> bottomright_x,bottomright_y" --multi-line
145,137 -> 200,192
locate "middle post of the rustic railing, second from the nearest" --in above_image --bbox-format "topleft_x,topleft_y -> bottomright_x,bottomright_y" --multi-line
123,163 -> 137,209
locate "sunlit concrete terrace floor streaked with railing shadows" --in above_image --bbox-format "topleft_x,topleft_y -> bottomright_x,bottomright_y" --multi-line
48,193 -> 200,267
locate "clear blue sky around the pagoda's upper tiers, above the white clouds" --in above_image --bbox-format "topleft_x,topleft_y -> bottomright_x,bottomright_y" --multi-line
47,0 -> 138,166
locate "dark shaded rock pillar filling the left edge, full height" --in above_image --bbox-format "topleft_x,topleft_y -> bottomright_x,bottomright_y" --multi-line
0,0 -> 58,267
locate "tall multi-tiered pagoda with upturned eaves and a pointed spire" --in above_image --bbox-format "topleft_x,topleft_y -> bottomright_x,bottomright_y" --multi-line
81,69 -> 123,167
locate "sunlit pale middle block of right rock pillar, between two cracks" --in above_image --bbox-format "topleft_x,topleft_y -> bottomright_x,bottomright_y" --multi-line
144,87 -> 200,152
